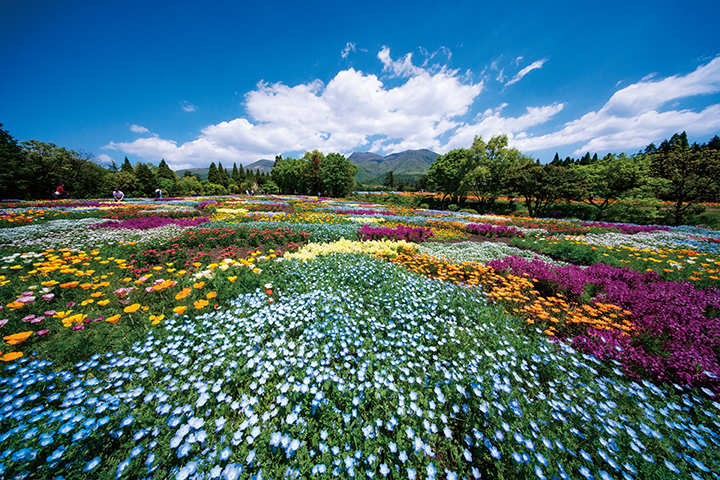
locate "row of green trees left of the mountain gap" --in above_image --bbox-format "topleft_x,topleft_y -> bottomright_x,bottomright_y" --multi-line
0,124 -> 357,200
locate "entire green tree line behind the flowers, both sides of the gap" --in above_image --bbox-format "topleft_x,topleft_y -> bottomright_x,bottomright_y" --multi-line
0,124 -> 720,224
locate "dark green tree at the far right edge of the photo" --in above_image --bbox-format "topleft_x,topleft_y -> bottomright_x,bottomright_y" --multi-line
650,132 -> 720,225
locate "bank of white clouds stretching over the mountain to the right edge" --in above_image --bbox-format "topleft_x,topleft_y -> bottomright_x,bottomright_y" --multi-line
105,50 -> 720,170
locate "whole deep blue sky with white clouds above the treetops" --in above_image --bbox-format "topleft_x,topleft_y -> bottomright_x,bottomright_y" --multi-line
0,0 -> 720,169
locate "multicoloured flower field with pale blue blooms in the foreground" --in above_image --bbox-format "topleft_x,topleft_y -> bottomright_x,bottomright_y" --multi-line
0,196 -> 720,480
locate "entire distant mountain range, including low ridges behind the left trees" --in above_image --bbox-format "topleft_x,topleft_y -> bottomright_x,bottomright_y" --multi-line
176,149 -> 440,185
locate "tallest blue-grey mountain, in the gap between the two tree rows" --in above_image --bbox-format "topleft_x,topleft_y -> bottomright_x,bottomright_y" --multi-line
348,149 -> 440,184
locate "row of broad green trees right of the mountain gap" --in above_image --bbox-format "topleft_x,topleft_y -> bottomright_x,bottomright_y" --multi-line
428,132 -> 720,224
